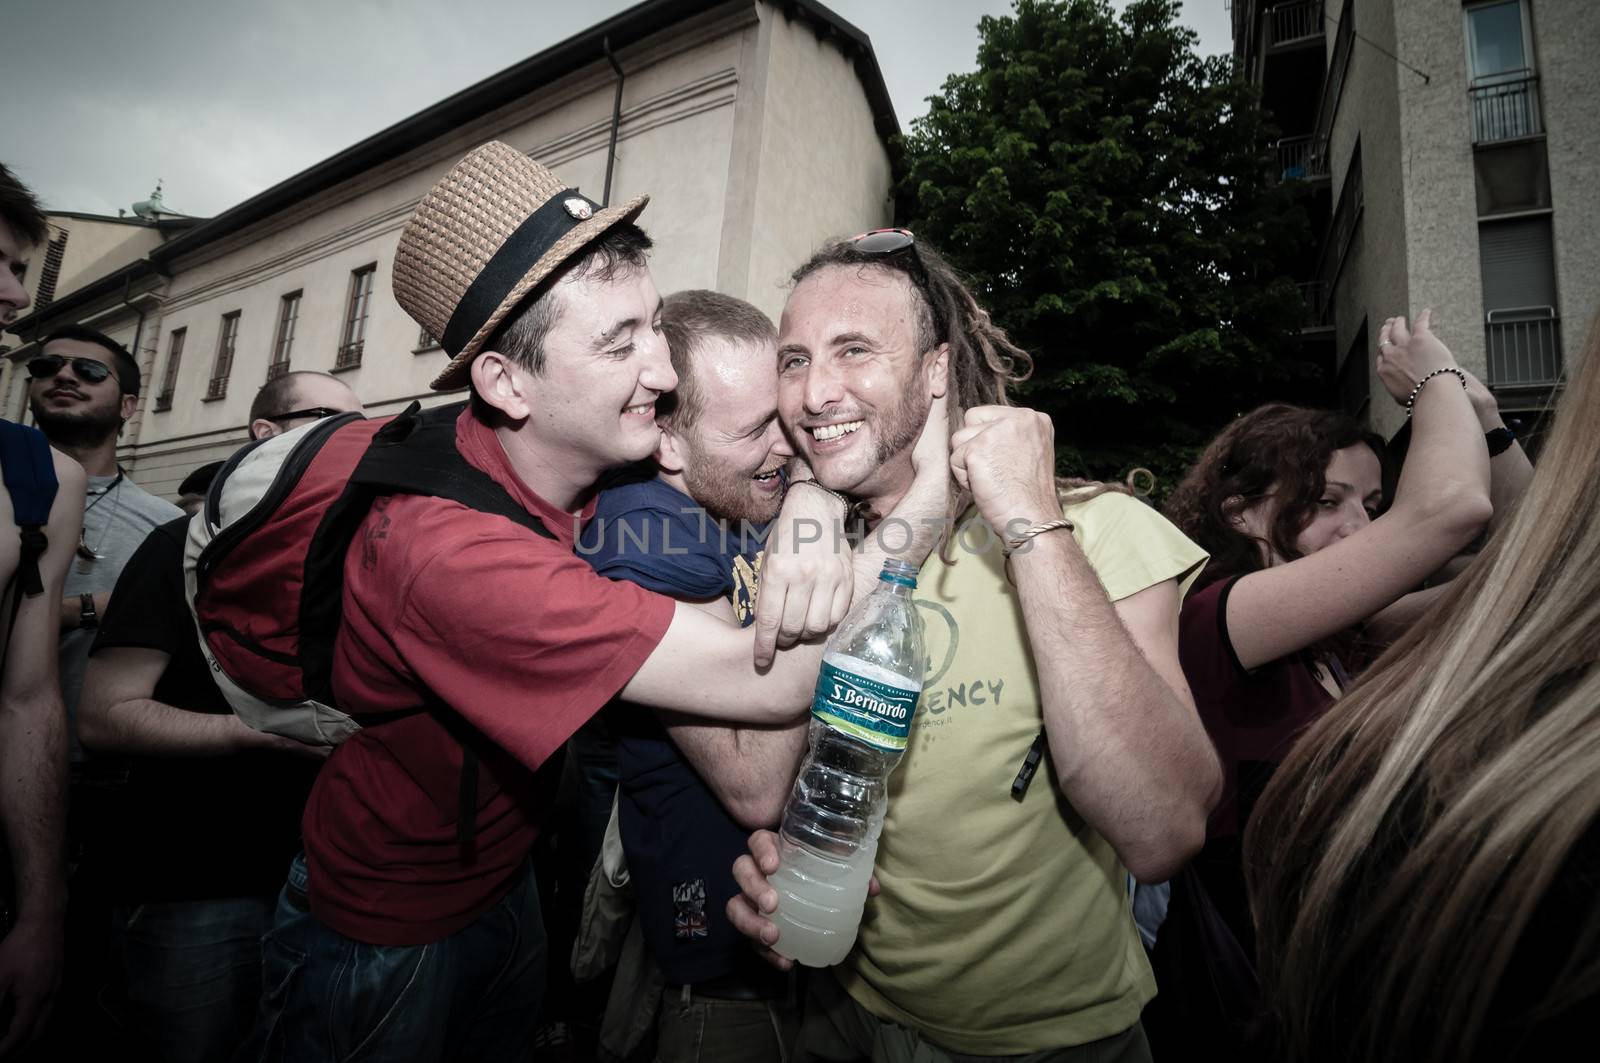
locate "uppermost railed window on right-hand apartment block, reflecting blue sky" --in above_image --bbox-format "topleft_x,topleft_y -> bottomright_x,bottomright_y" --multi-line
1466,0 -> 1544,144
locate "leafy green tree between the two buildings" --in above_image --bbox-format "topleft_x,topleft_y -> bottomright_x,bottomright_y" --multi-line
898,0 -> 1318,493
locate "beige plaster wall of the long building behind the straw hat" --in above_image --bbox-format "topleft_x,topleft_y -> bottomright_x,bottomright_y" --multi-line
21,0 -> 891,496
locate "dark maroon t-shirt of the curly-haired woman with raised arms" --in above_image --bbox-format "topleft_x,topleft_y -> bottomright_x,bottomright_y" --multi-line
1178,576 -> 1333,839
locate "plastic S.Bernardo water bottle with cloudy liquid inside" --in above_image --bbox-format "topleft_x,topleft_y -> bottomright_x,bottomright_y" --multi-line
771,559 -> 923,967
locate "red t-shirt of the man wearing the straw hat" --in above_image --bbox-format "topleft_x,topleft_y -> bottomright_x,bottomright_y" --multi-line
302,410 -> 674,945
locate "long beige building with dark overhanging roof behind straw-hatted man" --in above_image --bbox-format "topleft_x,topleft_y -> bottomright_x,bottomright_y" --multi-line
0,0 -> 899,496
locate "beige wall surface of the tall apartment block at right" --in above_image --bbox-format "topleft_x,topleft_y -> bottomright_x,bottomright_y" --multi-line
1326,0 -> 1600,434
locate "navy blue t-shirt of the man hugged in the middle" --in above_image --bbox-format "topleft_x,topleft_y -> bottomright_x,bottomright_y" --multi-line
579,479 -> 765,985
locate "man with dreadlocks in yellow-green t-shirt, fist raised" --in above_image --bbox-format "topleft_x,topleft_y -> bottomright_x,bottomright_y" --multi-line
728,231 -> 1221,1060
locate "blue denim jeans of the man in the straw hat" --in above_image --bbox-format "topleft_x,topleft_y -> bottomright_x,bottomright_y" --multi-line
237,855 -> 546,1063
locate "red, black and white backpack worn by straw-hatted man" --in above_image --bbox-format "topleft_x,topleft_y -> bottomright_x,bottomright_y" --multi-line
184,402 -> 555,819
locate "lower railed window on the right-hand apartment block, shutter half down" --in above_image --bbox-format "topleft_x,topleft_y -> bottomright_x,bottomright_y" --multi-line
1478,215 -> 1562,386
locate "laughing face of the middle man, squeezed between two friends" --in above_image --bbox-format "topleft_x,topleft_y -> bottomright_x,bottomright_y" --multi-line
658,336 -> 794,522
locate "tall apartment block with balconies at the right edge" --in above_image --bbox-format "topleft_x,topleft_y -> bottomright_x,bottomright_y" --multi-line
1232,0 -> 1600,434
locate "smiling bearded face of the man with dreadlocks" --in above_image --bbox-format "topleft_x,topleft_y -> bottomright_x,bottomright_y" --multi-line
778,266 -> 934,512
